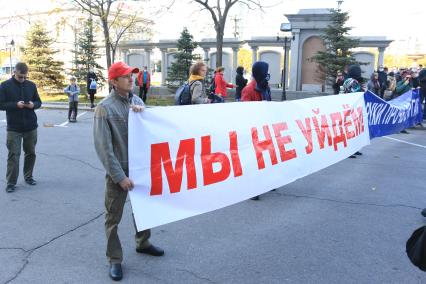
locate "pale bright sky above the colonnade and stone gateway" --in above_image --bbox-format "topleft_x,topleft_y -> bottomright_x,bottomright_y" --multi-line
0,0 -> 426,52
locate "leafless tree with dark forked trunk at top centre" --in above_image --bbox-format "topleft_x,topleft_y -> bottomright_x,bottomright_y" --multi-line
194,0 -> 264,67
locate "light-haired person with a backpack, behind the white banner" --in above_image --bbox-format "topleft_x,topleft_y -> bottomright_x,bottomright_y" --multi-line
188,62 -> 210,104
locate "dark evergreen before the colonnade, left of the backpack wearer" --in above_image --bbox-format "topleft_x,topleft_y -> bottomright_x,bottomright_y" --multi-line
167,28 -> 200,88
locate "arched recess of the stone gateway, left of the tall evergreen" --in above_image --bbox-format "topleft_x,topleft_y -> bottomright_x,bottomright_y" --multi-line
301,36 -> 325,92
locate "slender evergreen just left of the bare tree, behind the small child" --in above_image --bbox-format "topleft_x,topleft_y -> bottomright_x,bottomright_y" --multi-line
72,18 -> 105,92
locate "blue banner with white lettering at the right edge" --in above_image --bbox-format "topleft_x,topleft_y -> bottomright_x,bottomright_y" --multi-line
364,89 -> 423,139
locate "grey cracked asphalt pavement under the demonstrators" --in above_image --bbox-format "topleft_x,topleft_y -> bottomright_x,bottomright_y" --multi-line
0,107 -> 426,283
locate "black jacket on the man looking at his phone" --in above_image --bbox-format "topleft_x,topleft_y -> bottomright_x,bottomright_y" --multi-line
0,77 -> 41,132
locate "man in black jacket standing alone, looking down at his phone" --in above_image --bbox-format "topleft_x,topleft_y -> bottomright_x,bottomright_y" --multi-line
0,62 -> 41,192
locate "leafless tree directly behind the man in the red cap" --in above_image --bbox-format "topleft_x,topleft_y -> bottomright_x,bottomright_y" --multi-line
72,0 -> 151,68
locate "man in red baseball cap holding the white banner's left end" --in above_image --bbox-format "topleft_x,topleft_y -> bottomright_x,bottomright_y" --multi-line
93,62 -> 164,281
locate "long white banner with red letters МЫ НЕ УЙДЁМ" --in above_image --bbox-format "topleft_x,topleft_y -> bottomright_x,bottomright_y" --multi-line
129,93 -> 370,231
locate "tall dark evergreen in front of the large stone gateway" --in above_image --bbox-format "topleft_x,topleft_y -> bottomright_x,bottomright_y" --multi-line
311,9 -> 361,83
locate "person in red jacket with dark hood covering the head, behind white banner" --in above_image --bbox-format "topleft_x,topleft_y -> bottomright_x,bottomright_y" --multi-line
241,61 -> 275,200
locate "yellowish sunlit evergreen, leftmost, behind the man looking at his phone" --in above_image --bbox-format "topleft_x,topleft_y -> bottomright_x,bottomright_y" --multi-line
22,22 -> 64,92
